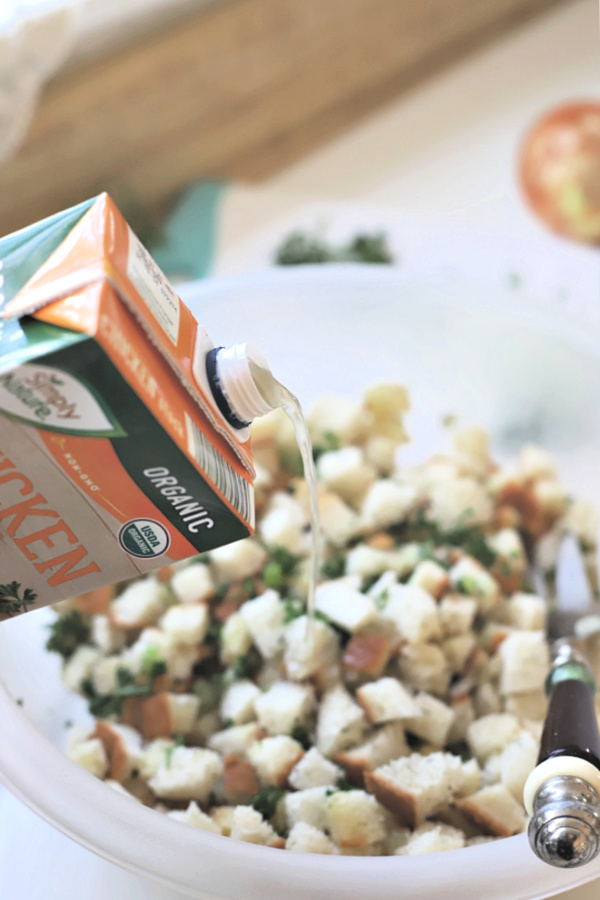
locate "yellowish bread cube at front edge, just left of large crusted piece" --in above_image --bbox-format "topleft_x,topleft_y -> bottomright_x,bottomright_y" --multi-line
325,790 -> 385,848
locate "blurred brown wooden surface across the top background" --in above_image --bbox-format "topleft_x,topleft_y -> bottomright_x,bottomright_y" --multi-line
0,0 -> 568,234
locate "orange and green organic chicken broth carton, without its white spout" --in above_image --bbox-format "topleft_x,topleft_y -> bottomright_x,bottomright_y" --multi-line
0,194 -> 254,619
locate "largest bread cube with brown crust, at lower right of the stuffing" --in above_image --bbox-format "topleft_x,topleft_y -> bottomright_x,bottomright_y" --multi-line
365,752 -> 472,829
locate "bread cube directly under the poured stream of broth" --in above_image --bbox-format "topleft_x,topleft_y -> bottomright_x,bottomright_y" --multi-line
283,616 -> 340,681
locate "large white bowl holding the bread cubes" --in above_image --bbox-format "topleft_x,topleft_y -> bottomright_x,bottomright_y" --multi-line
0,266 -> 600,900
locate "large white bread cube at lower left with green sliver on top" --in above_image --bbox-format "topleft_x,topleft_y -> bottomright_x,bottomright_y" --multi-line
148,747 -> 223,805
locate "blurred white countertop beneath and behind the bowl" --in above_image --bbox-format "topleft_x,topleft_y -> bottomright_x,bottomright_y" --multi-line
0,0 -> 600,900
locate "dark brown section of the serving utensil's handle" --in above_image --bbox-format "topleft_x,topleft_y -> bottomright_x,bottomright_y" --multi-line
537,678 -> 600,769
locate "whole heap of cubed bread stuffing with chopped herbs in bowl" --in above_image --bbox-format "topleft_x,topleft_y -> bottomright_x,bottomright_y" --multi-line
48,384 -> 600,865
